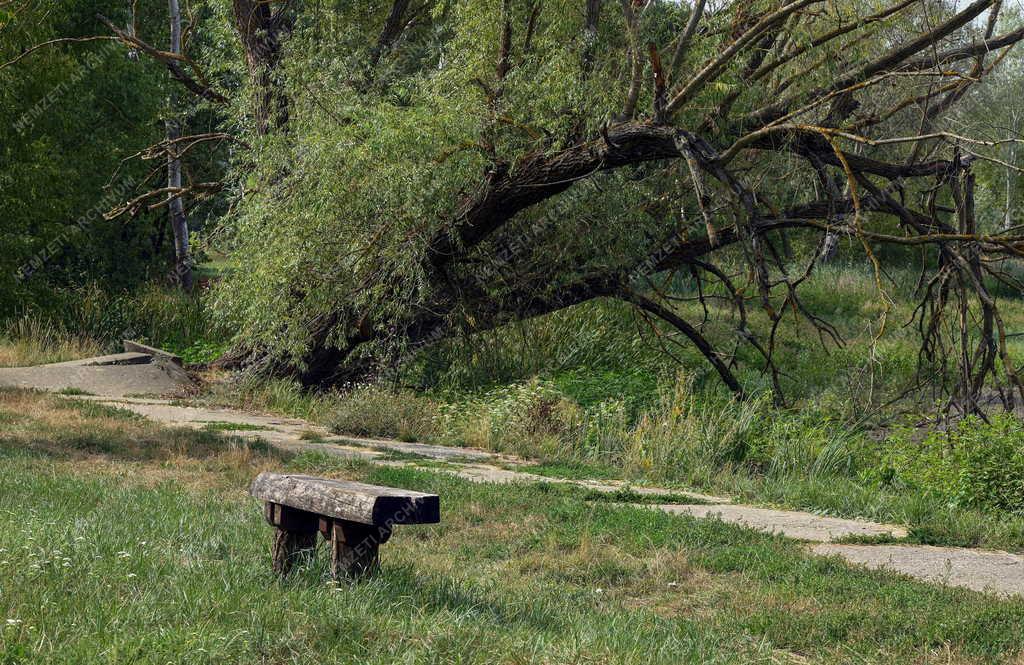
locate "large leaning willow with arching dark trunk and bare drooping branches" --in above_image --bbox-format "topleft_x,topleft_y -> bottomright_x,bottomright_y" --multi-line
207,0 -> 1024,409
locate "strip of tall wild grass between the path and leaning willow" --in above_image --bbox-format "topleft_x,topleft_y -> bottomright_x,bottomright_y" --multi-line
318,373 -> 863,485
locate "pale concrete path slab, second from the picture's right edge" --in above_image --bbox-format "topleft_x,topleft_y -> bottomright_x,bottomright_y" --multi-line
652,505 -> 906,543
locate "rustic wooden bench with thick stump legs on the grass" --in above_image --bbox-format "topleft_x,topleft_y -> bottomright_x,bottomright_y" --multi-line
250,472 -> 441,579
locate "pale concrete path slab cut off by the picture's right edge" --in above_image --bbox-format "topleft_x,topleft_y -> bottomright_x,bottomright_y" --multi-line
811,543 -> 1024,596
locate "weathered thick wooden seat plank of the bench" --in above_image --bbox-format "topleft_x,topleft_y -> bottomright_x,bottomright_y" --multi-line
250,472 -> 441,526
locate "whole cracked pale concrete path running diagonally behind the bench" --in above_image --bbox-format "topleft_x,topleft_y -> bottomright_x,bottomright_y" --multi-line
8,345 -> 1024,596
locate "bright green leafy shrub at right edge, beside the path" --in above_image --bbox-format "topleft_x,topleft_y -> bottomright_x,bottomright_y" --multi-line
878,414 -> 1024,512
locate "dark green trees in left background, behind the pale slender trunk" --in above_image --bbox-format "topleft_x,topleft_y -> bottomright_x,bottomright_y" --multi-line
0,1 -> 229,316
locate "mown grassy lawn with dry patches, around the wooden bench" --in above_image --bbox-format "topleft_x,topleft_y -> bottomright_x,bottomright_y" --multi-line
0,391 -> 1024,665
